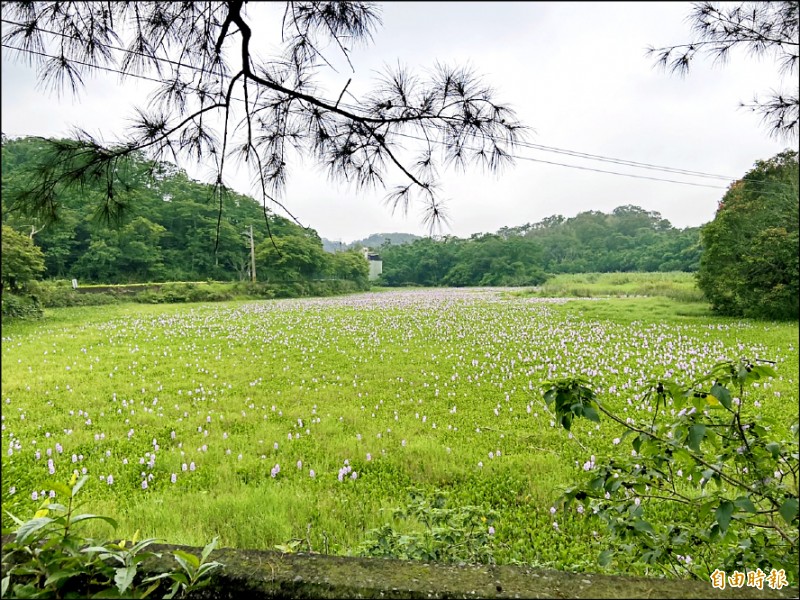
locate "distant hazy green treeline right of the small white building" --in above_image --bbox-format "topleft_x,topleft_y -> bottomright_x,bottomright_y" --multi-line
380,206 -> 701,286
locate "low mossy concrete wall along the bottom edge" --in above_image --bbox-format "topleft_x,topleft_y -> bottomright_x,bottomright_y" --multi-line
141,546 -> 798,600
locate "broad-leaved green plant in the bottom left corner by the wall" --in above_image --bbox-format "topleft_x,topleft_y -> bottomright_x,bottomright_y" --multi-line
2,475 -> 222,598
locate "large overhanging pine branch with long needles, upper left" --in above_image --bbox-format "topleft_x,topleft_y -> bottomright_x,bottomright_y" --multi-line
2,0 -> 525,234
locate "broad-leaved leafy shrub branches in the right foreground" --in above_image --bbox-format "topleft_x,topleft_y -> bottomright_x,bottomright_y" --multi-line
544,359 -> 800,583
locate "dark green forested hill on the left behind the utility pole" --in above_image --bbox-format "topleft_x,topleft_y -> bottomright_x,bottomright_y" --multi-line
2,138 -> 367,283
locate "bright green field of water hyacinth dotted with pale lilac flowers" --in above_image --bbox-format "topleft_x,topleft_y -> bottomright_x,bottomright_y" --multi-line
0,292 -> 798,585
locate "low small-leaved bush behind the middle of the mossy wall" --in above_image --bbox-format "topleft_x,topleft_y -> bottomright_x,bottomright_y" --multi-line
358,490 -> 497,564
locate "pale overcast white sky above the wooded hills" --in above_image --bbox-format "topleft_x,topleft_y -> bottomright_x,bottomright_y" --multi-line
2,2 -> 788,242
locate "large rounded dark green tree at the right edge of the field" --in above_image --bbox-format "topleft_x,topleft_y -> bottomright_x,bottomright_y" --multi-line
697,150 -> 800,319
